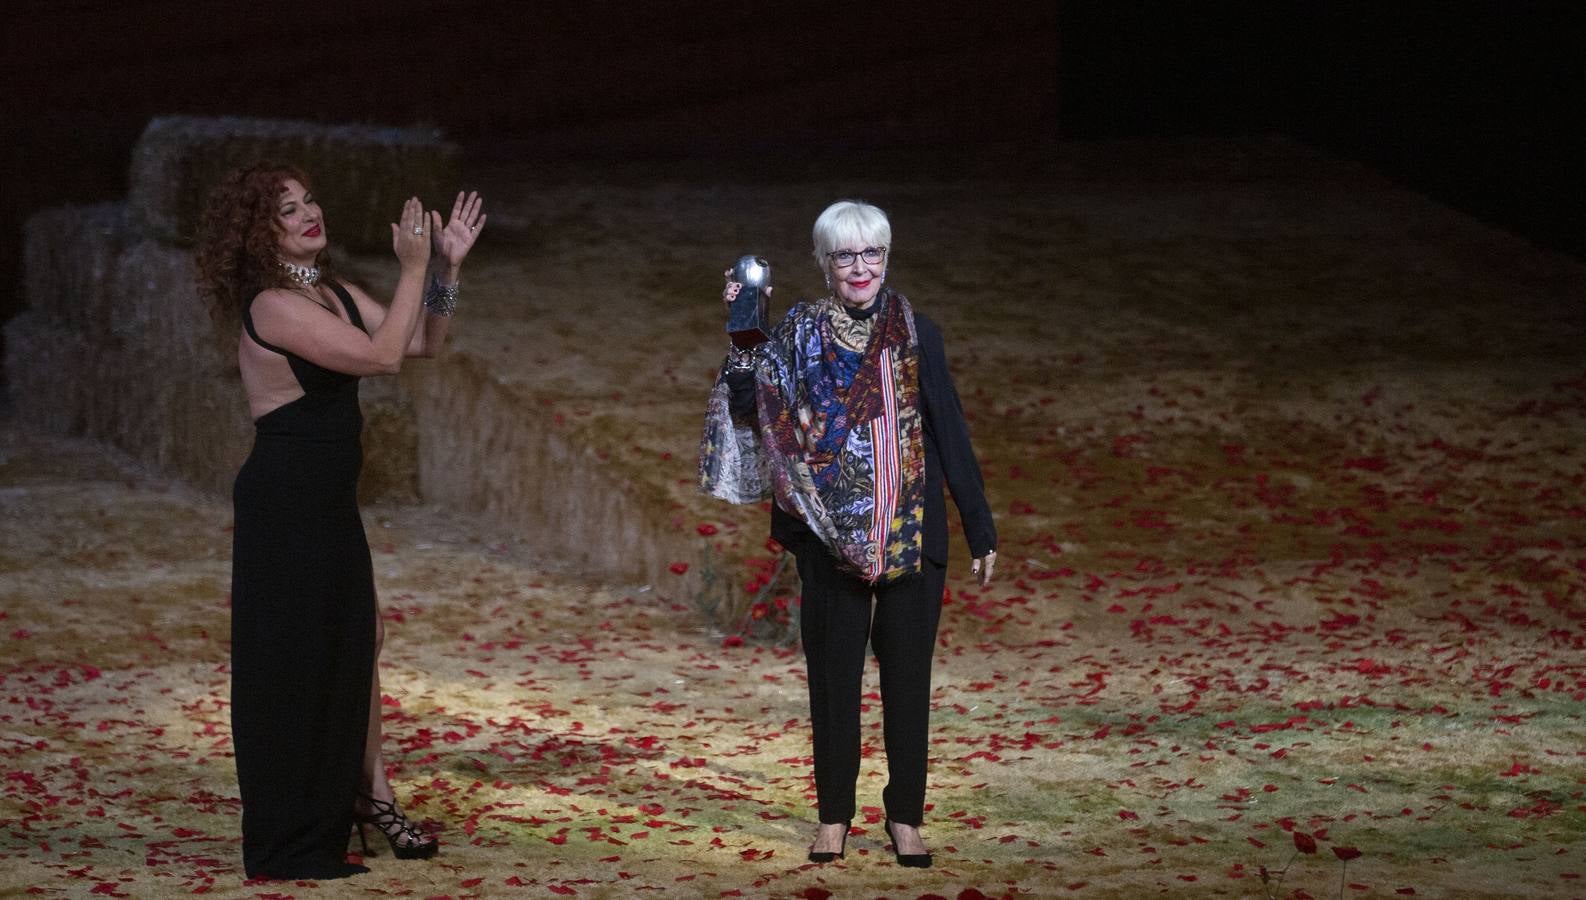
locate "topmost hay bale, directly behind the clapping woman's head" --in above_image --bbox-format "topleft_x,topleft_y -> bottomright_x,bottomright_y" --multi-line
128,116 -> 457,251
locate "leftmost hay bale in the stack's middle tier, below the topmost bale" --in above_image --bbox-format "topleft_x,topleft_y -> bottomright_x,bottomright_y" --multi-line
22,203 -> 133,335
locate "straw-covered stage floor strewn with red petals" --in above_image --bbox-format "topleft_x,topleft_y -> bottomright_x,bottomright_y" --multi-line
0,141 -> 1586,900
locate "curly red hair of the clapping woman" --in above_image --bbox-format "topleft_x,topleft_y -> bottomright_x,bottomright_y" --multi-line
197,162 -> 331,335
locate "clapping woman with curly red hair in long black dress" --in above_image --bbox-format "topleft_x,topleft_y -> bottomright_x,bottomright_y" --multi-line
198,163 -> 485,878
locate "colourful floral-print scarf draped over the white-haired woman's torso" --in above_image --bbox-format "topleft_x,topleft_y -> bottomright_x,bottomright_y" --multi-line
699,290 -> 925,583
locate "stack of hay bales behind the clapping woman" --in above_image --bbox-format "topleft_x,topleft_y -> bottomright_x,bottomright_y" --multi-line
5,116 -> 457,500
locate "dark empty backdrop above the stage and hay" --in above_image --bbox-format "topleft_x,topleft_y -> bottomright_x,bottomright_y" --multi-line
0,0 -> 1586,382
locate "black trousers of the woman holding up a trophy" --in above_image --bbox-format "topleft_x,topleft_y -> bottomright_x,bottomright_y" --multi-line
796,544 -> 947,827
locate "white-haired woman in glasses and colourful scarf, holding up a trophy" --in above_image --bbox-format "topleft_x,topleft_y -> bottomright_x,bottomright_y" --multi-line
699,200 -> 996,868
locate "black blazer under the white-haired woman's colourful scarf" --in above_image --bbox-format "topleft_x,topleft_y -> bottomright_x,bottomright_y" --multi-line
726,311 -> 996,565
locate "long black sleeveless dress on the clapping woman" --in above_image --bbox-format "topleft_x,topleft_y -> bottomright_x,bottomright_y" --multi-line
232,284 -> 376,878
